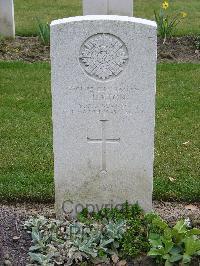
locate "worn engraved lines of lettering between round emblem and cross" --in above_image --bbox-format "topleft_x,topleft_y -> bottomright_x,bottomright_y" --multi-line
65,86 -> 141,114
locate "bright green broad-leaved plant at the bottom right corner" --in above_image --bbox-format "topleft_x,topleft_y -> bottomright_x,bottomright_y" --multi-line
148,216 -> 200,266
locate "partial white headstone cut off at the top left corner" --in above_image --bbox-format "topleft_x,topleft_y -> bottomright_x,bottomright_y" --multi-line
0,0 -> 15,38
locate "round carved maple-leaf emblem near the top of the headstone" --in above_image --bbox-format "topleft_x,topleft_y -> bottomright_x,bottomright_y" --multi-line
79,33 -> 128,81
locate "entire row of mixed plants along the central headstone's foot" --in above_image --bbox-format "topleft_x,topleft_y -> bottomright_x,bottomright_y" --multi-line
24,203 -> 200,266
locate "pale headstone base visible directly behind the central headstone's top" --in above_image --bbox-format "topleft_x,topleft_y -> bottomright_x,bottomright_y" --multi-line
83,0 -> 133,17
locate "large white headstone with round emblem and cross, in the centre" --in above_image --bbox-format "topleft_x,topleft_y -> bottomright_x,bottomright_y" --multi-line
51,16 -> 157,216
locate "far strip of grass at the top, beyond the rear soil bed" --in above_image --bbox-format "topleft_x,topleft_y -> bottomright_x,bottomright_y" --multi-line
15,0 -> 200,35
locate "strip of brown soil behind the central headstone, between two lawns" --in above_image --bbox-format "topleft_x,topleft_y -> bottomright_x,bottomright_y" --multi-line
0,36 -> 200,63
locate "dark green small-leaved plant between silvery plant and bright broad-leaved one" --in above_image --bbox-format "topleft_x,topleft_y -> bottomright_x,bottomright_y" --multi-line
78,202 -> 149,258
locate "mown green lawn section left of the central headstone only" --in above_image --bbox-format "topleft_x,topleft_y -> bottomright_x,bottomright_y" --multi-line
0,62 -> 53,201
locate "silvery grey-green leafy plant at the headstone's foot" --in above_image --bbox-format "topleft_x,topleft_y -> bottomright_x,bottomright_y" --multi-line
24,216 -> 126,266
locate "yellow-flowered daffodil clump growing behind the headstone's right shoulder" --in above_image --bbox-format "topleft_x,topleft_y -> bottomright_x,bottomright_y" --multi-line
154,1 -> 187,44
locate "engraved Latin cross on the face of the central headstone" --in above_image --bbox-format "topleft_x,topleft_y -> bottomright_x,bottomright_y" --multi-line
87,120 -> 120,172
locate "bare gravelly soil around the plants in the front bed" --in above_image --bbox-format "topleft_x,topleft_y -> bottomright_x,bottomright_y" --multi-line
0,201 -> 200,266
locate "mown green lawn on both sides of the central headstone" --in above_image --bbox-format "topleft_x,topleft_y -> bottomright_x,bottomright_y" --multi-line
0,62 -> 200,202
